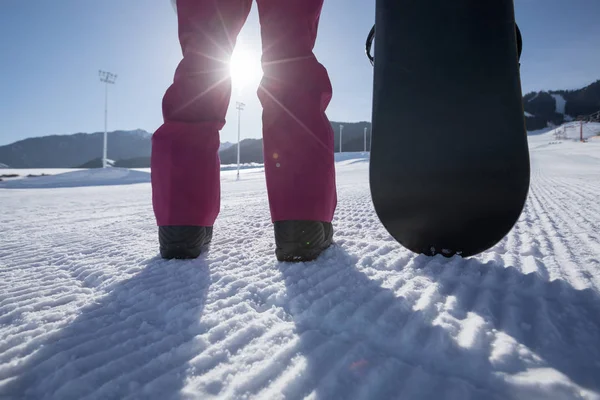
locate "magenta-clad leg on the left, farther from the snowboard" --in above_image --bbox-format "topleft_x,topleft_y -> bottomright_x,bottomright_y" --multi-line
151,0 -> 252,253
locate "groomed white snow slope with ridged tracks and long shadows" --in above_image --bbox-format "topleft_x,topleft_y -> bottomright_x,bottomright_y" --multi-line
0,137 -> 600,400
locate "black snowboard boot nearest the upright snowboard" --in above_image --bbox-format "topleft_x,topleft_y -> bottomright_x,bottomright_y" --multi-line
275,221 -> 333,262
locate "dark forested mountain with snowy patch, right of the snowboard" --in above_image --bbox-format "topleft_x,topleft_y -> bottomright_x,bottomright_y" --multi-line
523,80 -> 600,131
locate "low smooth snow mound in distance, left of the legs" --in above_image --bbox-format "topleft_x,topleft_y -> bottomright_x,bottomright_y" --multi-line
0,168 -> 150,189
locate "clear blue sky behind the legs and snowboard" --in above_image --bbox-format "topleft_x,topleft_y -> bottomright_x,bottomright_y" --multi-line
0,0 -> 600,145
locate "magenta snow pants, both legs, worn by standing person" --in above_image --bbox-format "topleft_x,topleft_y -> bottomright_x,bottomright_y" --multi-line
151,0 -> 337,226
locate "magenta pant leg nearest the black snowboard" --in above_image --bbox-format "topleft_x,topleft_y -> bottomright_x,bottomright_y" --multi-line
257,0 -> 337,222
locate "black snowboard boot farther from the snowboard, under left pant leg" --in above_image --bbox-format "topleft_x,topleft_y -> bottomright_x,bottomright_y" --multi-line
158,226 -> 212,259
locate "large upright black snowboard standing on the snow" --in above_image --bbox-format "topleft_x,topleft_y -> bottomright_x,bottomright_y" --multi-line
370,0 -> 530,257
